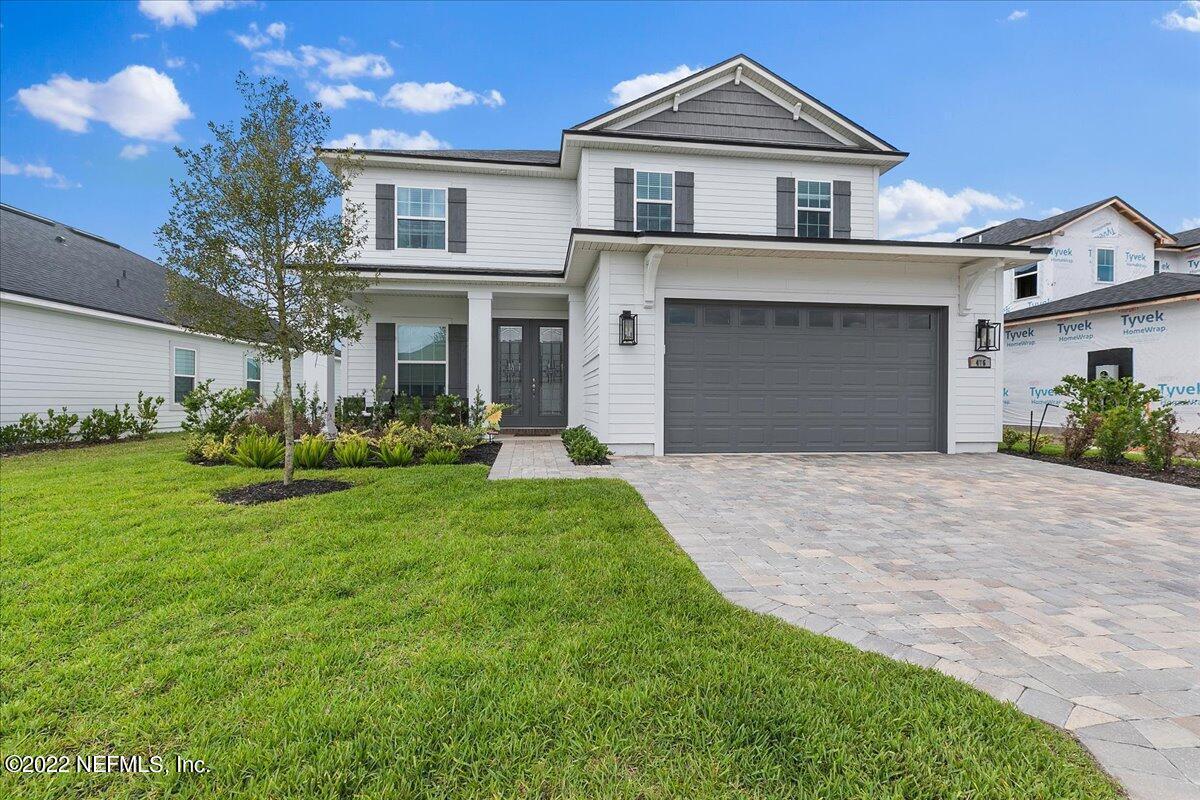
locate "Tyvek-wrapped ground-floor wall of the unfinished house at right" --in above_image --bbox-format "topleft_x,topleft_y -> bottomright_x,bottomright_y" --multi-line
1003,300 -> 1200,433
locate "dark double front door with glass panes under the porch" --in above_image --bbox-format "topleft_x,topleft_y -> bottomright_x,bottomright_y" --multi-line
492,319 -> 566,428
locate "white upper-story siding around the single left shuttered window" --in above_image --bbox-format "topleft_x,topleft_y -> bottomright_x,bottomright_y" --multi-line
347,167 -> 576,271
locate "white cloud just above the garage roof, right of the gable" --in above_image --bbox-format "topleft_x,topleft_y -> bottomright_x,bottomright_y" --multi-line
880,179 -> 1025,239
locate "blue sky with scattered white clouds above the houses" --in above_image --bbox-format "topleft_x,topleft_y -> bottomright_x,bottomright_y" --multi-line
0,0 -> 1200,257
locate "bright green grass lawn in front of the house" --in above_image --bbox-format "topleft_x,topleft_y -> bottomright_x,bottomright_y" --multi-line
0,437 -> 1118,800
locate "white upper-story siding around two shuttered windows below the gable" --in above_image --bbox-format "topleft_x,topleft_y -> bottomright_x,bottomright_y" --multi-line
580,149 -> 877,239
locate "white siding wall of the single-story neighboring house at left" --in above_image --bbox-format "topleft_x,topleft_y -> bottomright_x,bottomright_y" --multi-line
0,302 -> 285,431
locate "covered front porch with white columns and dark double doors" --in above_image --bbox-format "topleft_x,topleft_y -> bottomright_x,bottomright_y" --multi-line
338,281 -> 583,431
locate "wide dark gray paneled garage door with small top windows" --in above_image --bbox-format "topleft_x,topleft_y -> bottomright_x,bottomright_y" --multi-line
665,300 -> 946,453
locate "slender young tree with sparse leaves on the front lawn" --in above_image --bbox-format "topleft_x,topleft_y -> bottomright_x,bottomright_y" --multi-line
156,73 -> 367,483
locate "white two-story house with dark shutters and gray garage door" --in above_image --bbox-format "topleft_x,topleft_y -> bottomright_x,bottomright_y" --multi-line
330,55 -> 1049,455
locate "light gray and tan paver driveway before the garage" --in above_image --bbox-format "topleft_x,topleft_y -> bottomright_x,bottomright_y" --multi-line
614,455 -> 1200,800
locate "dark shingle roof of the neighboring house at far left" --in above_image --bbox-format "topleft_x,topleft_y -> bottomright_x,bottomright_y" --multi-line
0,205 -> 170,324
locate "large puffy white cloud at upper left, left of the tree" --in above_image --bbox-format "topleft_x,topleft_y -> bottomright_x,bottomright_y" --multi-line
17,65 -> 192,142
